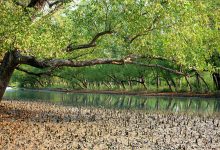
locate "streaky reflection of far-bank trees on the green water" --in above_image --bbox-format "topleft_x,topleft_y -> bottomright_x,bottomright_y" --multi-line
49,94 -> 220,112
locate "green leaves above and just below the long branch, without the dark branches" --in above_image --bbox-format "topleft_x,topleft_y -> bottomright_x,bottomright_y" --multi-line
0,0 -> 220,91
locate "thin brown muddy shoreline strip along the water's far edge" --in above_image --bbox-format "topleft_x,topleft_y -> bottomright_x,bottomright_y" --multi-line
15,88 -> 220,98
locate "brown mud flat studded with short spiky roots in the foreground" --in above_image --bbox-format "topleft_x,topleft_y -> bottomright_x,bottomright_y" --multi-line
0,101 -> 220,150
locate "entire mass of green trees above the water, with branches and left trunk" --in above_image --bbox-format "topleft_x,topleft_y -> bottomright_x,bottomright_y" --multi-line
0,0 -> 220,97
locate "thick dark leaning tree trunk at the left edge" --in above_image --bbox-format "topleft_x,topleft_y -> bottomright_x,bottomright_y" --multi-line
0,51 -> 18,101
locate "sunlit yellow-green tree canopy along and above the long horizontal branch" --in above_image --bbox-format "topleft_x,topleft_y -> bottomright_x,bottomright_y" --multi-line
0,0 -> 220,98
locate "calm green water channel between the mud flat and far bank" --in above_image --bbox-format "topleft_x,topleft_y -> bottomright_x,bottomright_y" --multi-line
4,89 -> 220,113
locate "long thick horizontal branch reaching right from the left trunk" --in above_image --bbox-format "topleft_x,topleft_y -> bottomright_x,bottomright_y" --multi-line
19,51 -> 188,76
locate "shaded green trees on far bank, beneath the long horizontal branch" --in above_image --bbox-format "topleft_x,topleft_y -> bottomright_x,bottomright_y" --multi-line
11,65 -> 215,92
